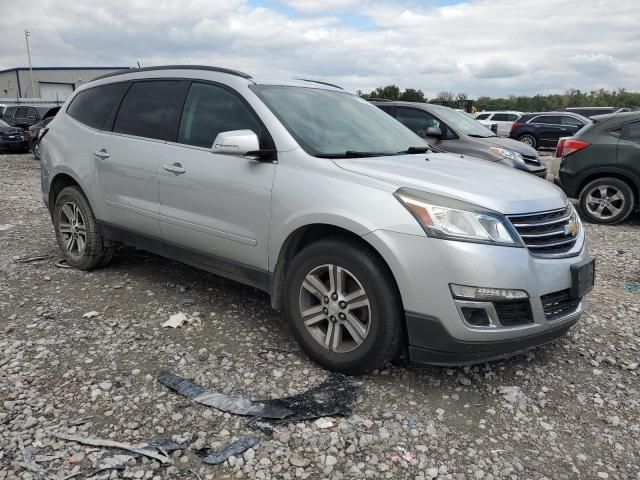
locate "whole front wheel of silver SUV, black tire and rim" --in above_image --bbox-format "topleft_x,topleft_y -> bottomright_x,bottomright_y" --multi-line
284,238 -> 404,375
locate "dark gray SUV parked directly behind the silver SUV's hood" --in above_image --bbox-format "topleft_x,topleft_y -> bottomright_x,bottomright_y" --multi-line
371,100 -> 547,178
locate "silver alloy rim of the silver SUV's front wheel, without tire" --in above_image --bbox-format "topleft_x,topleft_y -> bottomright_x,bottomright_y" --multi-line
299,264 -> 371,353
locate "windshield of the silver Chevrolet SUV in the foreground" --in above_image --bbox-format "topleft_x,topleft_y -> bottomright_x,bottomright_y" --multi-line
251,85 -> 428,158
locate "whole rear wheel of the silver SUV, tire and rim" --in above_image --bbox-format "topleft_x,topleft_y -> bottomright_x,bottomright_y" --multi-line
53,187 -> 111,270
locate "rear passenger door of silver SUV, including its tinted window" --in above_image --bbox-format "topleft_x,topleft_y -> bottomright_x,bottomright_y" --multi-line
93,80 -> 187,240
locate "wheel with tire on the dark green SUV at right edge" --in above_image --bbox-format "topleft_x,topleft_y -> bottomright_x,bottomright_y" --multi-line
580,177 -> 635,225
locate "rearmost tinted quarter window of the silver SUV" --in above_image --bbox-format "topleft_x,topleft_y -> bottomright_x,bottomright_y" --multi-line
67,83 -> 127,130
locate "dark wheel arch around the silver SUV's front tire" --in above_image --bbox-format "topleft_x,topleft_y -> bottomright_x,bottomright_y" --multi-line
270,223 -> 402,310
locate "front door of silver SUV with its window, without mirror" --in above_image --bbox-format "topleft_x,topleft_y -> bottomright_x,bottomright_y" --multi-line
158,82 -> 275,276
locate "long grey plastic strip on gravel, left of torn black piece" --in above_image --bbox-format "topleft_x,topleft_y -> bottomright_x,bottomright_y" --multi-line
156,370 -> 293,418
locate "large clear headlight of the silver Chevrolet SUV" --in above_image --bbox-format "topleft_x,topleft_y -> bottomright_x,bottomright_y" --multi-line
394,188 -> 522,247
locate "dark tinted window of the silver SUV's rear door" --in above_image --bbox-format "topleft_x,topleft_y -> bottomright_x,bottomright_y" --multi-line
113,80 -> 184,140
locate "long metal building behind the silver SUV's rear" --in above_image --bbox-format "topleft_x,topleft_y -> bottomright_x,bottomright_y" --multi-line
0,67 -> 129,102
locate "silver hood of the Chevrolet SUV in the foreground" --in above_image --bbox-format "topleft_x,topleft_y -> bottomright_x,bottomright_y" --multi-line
335,153 -> 567,214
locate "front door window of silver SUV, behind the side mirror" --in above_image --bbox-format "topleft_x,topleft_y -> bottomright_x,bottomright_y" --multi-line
178,83 -> 263,148
